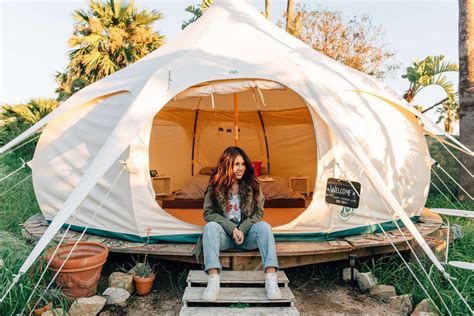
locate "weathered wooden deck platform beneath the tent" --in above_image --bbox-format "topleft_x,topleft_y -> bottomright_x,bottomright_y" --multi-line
22,214 -> 442,270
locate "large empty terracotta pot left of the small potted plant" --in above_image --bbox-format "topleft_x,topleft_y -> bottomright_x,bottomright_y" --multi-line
46,241 -> 109,298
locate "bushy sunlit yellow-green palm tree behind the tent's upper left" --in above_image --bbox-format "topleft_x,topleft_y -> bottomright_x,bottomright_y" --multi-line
56,0 -> 164,99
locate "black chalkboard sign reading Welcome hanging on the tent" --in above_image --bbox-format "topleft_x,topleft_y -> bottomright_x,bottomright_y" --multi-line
326,178 -> 360,208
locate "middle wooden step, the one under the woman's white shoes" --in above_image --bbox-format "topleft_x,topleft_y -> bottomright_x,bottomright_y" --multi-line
183,287 -> 295,307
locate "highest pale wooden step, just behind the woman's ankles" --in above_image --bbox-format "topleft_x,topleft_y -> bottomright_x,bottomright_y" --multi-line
186,270 -> 290,287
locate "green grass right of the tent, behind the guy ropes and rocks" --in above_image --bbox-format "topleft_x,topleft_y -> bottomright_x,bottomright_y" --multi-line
361,196 -> 474,315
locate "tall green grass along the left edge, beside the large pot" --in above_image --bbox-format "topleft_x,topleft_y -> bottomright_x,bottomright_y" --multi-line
0,143 -> 67,315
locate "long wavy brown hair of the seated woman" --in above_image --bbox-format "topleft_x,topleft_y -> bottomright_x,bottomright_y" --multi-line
209,146 -> 260,215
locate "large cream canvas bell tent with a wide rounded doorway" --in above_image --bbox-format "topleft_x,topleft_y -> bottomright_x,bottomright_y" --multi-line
2,0 -> 472,273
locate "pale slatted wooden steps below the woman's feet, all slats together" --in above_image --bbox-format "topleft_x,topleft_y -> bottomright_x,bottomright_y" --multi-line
180,270 -> 299,316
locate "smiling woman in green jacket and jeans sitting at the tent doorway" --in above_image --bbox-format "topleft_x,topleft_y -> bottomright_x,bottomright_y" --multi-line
202,147 -> 281,301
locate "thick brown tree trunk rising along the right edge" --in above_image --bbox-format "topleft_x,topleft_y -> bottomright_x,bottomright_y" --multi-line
459,0 -> 474,200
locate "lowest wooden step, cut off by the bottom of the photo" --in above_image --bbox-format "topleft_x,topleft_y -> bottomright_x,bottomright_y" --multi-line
179,307 -> 300,316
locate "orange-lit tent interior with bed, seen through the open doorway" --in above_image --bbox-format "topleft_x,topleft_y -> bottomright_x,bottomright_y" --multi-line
149,79 -> 317,227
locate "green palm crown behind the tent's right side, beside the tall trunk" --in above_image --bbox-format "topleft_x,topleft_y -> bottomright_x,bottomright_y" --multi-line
402,55 -> 459,133
